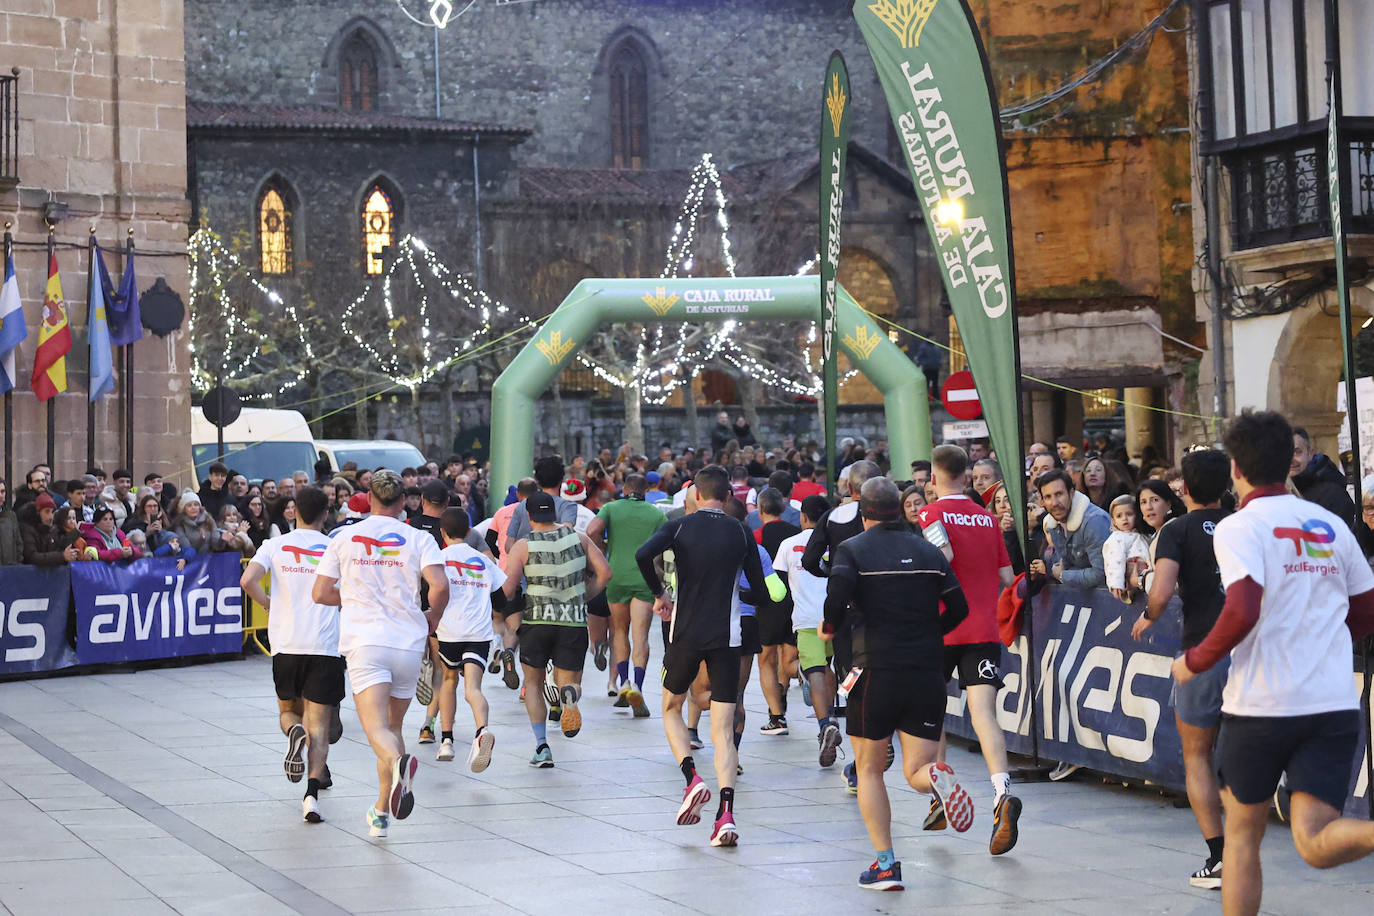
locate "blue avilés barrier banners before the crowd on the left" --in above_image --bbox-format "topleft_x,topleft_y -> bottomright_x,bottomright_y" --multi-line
0,553 -> 243,677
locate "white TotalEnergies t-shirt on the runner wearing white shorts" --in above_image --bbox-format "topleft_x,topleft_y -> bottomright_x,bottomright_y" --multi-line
317,515 -> 444,655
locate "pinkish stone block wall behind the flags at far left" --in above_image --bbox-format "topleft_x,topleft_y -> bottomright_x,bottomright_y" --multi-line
0,0 -> 190,479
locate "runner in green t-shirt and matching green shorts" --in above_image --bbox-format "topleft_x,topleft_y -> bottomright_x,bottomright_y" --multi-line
587,474 -> 665,718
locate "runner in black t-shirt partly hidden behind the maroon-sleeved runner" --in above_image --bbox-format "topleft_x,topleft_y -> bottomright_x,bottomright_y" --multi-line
1131,449 -> 1231,890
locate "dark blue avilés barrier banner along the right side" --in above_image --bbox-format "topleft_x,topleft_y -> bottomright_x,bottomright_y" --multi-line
945,586 -> 1370,817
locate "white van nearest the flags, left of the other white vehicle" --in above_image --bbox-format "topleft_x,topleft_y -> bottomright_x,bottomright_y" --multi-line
191,407 -> 317,481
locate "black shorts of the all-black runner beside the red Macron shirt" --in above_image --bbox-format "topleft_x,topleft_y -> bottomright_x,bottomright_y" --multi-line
845,667 -> 945,742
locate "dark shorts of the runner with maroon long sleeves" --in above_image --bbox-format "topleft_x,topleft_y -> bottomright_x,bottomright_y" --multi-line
1216,710 -> 1360,812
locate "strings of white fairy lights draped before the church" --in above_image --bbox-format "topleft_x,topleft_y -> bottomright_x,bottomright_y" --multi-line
188,154 -> 857,405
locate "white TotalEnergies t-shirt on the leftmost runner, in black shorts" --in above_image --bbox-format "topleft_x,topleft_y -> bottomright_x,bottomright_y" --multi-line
253,527 -> 339,656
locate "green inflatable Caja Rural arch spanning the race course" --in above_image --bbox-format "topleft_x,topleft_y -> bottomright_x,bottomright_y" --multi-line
491,276 -> 930,494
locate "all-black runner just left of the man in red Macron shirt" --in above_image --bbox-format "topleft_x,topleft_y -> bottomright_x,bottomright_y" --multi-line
820,478 -> 973,890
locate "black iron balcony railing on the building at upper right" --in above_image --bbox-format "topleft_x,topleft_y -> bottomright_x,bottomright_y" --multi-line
1221,129 -> 1374,251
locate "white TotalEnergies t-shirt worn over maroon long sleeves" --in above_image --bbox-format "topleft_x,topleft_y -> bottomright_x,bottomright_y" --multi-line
1213,494 -> 1374,715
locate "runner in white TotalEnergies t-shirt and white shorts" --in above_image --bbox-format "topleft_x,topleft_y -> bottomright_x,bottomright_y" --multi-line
312,470 -> 448,836
